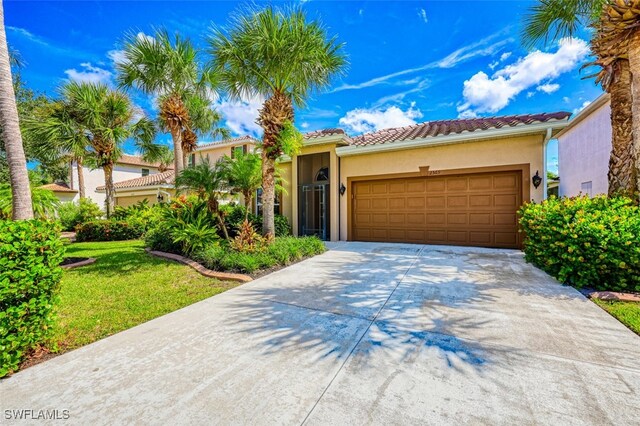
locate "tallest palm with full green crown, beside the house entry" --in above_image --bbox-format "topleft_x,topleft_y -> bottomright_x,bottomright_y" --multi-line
208,6 -> 347,235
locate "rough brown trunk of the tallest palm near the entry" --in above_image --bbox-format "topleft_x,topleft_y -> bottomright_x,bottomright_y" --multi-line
258,92 -> 293,236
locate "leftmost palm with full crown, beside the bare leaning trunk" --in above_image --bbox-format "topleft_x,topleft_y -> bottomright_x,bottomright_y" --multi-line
22,101 -> 90,198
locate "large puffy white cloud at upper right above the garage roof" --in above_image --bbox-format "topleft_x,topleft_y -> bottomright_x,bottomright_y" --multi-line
458,38 -> 589,113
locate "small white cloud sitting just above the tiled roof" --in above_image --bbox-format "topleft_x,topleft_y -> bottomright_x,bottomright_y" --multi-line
340,102 -> 422,133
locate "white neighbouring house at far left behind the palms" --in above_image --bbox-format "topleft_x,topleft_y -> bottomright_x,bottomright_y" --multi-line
70,154 -> 168,209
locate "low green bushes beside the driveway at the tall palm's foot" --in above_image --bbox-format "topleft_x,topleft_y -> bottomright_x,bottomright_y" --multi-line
195,237 -> 325,273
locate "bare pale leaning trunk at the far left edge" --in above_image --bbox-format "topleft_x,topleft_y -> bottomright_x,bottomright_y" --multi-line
0,1 -> 33,220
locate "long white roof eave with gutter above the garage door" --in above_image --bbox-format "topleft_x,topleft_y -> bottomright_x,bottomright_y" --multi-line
336,120 -> 568,157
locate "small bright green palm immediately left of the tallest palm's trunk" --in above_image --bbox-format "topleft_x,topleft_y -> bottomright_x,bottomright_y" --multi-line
220,153 -> 262,219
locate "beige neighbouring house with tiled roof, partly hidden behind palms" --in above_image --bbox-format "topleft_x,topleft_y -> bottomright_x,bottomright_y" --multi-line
102,136 -> 258,207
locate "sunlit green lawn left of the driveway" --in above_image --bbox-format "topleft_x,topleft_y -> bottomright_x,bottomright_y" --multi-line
51,241 -> 236,350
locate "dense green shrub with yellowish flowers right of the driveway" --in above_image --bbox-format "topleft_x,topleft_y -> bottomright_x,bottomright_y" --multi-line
519,196 -> 640,291
